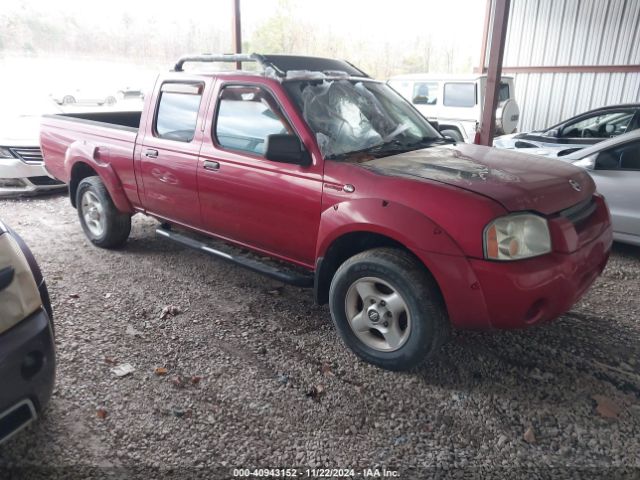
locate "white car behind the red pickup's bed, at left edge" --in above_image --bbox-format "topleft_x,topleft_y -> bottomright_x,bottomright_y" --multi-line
0,97 -> 66,197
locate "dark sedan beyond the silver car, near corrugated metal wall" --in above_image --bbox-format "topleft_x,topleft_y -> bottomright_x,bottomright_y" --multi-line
493,103 -> 640,157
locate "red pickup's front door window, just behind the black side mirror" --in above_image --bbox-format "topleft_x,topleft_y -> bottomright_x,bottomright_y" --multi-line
215,86 -> 293,155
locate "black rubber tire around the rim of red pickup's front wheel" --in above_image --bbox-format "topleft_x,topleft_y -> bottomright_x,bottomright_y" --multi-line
329,248 -> 450,370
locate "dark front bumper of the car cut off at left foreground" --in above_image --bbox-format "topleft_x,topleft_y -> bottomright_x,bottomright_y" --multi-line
0,309 -> 56,443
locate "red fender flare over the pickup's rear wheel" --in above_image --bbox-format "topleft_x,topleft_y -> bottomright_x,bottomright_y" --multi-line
64,140 -> 134,213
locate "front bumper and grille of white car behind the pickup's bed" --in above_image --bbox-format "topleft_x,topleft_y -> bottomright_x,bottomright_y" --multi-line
0,158 -> 66,197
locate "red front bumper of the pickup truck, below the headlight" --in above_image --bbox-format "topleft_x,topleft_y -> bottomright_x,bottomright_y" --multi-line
419,195 -> 613,330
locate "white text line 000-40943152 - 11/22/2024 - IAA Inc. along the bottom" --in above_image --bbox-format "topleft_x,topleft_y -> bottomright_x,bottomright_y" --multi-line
233,468 -> 400,478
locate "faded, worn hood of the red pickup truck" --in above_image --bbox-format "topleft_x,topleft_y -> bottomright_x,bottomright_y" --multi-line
360,144 -> 595,214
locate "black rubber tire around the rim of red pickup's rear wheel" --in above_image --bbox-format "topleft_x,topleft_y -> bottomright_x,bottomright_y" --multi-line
76,177 -> 131,248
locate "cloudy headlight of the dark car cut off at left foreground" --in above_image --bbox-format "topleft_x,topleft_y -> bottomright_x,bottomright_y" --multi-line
0,233 -> 42,333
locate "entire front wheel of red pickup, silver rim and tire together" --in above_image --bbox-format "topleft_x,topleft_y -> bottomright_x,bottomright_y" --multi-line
329,248 -> 449,370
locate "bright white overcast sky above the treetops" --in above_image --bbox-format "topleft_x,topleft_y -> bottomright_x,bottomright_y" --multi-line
0,0 -> 486,54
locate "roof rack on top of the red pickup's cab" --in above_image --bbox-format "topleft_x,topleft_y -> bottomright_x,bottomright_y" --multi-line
174,53 -> 369,78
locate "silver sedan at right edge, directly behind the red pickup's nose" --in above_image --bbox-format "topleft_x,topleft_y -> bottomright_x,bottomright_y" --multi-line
560,130 -> 640,246
